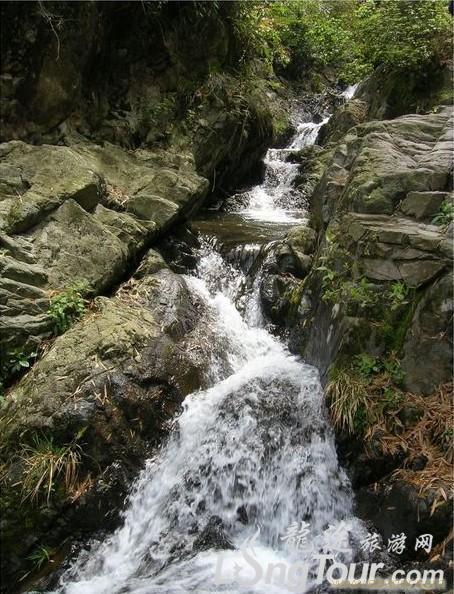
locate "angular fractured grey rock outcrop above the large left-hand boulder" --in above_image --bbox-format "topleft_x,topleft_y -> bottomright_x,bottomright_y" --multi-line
0,141 -> 208,345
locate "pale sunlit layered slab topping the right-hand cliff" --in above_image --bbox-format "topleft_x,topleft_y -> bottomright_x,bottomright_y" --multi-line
312,107 -> 453,225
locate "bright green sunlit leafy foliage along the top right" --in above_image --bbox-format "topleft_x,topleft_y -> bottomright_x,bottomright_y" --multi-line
255,0 -> 452,83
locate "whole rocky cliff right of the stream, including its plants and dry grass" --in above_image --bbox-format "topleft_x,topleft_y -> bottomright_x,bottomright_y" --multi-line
260,71 -> 453,551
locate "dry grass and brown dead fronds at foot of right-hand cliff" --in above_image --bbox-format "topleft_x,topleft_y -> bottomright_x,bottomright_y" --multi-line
327,361 -> 454,502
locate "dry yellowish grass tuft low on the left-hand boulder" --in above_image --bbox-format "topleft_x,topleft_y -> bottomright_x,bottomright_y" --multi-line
20,437 -> 81,501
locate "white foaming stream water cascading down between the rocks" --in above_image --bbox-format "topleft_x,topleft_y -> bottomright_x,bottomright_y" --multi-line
53,86 -> 367,594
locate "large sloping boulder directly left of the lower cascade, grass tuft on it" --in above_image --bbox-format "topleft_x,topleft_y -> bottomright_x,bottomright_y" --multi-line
0,252 -> 216,579
